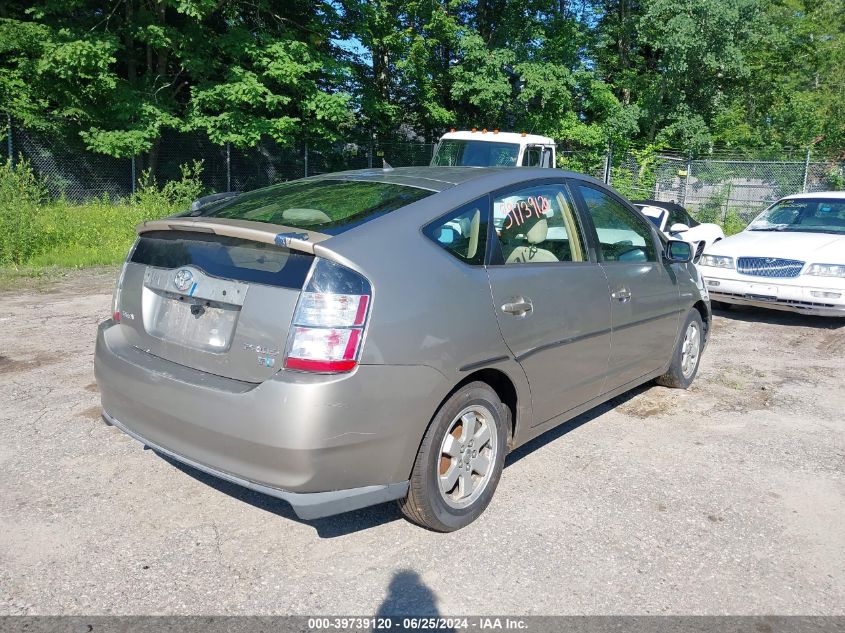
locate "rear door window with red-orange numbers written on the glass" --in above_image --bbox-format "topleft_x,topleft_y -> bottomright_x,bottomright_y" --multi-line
493,184 -> 587,264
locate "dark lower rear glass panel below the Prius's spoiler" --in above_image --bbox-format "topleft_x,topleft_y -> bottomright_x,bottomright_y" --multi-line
130,231 -> 314,289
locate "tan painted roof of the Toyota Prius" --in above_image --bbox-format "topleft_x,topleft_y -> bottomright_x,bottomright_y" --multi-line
309,167 -> 604,193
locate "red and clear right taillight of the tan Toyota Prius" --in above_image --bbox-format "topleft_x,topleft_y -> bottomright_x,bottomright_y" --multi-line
285,259 -> 372,373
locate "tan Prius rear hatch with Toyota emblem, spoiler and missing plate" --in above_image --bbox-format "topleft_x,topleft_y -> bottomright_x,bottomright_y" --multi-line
115,218 -> 328,383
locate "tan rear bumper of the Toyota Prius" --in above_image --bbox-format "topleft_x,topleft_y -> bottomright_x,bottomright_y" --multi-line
94,321 -> 446,518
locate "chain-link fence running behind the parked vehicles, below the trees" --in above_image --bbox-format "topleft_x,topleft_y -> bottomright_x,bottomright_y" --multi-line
3,119 -> 845,225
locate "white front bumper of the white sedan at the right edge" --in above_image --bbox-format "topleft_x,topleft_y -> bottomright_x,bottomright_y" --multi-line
702,268 -> 845,317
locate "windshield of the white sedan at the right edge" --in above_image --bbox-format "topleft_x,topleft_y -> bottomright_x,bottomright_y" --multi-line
748,198 -> 845,235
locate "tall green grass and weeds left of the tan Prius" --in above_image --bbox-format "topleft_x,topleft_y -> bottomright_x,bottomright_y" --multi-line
0,161 -> 202,271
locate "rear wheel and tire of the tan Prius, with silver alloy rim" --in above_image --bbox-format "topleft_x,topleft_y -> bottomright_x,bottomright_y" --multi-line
399,382 -> 508,532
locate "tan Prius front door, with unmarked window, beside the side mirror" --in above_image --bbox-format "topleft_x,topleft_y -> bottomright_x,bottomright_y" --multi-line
573,181 -> 680,391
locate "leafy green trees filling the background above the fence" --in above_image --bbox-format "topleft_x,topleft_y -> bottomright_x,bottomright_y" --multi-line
0,0 -> 845,158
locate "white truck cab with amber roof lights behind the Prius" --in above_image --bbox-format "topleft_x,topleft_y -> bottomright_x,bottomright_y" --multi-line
430,128 -> 556,167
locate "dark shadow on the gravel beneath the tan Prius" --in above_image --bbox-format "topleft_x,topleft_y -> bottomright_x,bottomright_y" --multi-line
157,383 -> 651,539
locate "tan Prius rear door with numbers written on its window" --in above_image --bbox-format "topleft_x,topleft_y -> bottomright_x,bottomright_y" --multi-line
487,181 -> 610,425
